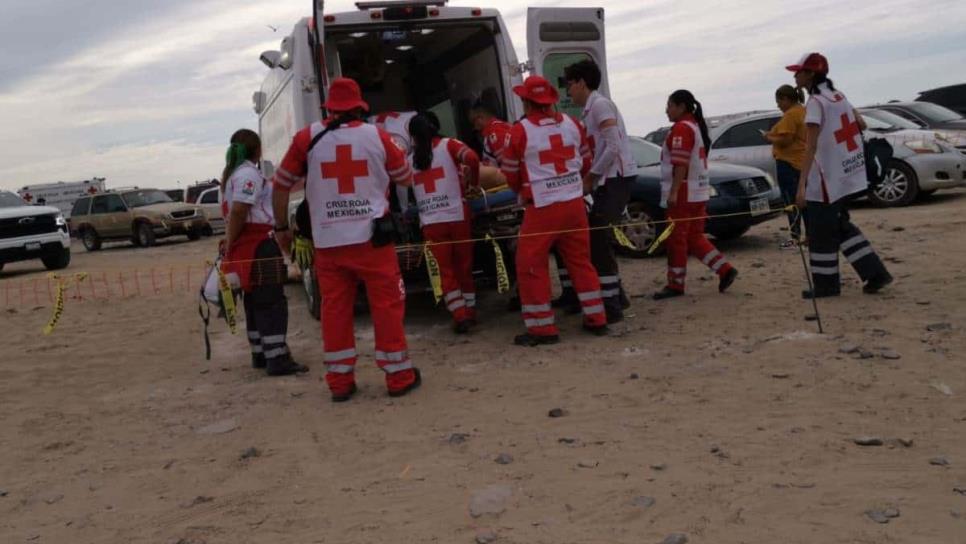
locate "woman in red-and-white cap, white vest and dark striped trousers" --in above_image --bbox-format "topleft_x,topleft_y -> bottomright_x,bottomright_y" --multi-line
786,53 -> 892,298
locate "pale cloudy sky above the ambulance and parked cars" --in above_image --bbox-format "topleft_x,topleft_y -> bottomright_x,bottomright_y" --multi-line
0,0 -> 966,190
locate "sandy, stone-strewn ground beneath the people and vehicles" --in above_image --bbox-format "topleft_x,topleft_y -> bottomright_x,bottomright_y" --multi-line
0,191 -> 966,544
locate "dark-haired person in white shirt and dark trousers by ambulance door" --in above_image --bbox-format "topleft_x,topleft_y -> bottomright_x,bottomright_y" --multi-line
560,60 -> 637,323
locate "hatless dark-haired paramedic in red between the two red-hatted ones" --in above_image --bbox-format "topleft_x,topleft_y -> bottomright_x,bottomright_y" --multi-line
409,113 -> 480,334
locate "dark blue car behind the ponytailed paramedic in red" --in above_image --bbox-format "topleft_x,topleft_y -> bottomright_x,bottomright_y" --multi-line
621,136 -> 785,257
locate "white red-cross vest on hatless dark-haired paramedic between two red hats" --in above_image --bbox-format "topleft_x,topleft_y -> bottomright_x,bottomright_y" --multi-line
413,138 -> 463,226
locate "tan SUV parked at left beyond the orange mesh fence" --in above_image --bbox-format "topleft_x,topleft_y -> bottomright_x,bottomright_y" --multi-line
70,189 -> 210,251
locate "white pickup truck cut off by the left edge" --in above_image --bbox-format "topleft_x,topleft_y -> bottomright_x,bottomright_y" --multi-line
0,191 -> 70,270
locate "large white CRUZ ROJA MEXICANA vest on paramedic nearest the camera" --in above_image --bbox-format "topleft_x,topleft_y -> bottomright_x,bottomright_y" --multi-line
305,122 -> 389,248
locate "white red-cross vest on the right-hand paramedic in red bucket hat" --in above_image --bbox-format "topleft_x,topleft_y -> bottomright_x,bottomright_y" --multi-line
520,115 -> 584,208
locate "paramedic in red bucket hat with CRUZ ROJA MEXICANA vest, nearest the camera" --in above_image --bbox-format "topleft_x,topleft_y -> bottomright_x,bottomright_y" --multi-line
274,78 -> 421,402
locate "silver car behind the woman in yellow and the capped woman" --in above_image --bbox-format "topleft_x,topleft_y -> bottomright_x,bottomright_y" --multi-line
708,111 -> 964,207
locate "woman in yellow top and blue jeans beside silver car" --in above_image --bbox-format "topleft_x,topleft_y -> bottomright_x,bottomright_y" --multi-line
764,85 -> 805,249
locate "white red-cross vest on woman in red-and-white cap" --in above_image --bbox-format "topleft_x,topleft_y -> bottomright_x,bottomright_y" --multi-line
805,86 -> 869,202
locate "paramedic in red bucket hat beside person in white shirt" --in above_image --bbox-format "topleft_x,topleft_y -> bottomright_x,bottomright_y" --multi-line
502,76 -> 607,346
